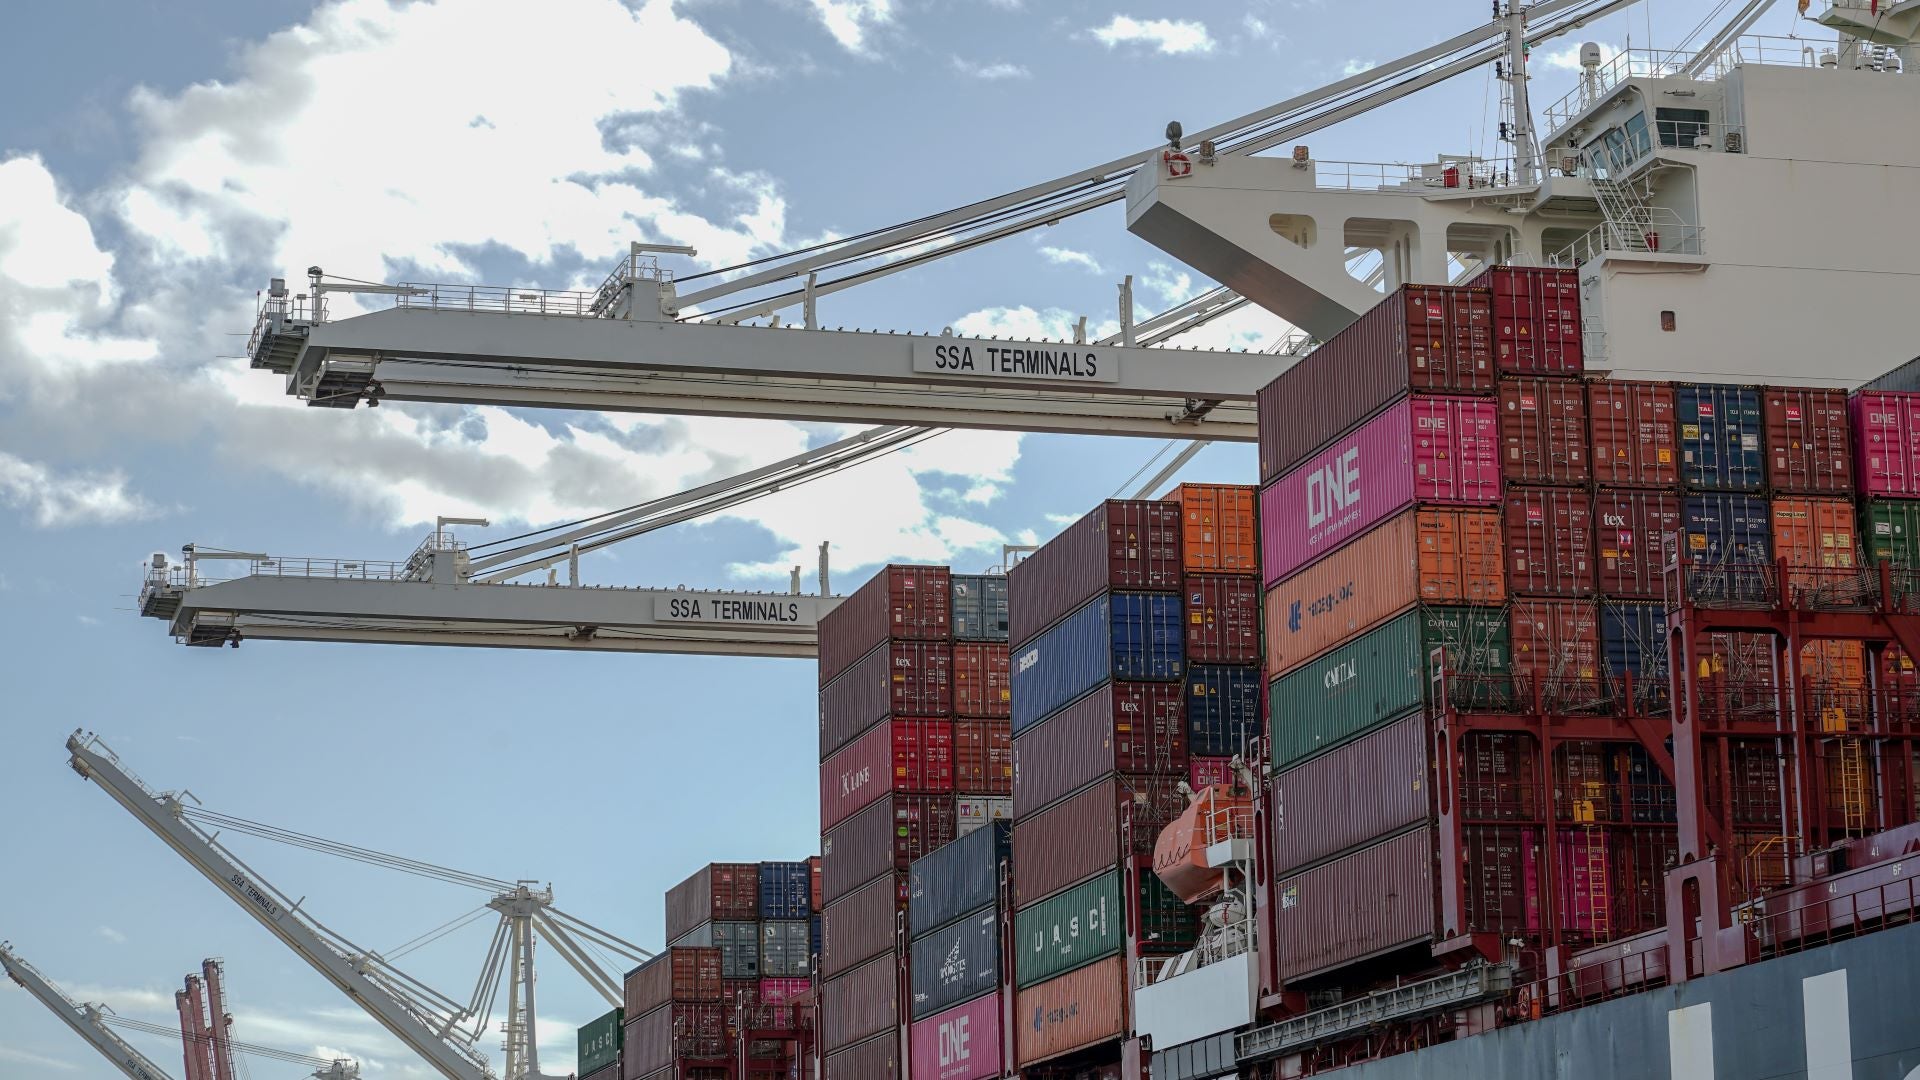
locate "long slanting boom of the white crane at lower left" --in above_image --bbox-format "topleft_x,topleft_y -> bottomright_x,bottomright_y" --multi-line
67,732 -> 493,1080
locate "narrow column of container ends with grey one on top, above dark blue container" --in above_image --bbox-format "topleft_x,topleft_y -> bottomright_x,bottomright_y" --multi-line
952,575 -> 1014,836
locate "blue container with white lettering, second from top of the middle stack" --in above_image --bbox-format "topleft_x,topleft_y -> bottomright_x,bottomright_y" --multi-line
1012,592 -> 1187,734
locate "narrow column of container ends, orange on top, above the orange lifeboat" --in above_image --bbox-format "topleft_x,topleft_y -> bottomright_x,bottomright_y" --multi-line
1171,484 -> 1265,776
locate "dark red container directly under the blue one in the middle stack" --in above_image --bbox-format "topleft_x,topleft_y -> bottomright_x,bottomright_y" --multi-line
1014,682 -> 1187,817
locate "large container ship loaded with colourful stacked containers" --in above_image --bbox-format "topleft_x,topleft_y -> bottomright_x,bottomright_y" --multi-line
86,0 -> 1920,1080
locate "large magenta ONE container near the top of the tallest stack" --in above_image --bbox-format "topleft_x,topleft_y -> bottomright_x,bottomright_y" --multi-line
1260,396 -> 1500,588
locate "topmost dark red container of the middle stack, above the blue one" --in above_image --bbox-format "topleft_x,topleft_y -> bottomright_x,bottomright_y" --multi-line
1006,500 -> 1185,646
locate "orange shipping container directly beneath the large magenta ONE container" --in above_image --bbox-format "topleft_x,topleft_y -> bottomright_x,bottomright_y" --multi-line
1265,507 -> 1507,678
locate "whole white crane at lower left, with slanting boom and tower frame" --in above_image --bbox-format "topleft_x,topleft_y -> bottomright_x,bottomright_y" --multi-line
67,732 -> 651,1080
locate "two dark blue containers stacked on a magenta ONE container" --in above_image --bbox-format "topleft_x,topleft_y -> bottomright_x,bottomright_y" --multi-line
906,821 -> 1012,1080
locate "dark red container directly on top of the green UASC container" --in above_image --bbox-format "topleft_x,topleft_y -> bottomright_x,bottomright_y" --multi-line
1014,768 -> 1187,907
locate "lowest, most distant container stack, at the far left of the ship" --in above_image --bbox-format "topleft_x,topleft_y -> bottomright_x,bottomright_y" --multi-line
622,861 -> 814,1080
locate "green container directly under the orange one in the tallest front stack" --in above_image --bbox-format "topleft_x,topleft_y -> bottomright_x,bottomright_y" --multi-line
1267,607 -> 1513,769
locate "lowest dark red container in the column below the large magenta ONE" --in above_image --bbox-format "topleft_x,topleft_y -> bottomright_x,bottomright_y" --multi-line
1269,828 -> 1434,984
